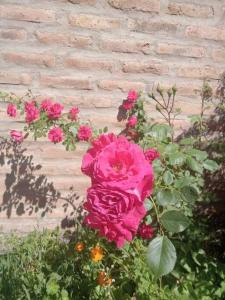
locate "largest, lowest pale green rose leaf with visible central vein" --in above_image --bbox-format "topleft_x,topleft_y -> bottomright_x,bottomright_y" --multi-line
147,236 -> 177,278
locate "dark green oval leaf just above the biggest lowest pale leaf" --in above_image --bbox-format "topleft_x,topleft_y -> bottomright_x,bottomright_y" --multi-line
160,210 -> 189,233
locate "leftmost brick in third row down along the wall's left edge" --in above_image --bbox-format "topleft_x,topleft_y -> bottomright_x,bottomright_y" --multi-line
3,52 -> 55,67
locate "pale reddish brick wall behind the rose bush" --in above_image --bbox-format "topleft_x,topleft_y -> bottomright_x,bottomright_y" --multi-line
0,0 -> 225,232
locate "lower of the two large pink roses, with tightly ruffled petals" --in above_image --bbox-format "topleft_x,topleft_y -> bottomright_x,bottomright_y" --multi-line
84,185 -> 146,248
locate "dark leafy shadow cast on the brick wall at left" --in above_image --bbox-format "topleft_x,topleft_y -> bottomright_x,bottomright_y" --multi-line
0,138 -> 82,228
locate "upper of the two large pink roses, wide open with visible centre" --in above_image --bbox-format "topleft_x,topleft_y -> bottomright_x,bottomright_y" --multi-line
81,134 -> 153,199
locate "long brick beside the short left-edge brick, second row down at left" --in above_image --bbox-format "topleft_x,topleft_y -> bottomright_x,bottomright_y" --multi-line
35,31 -> 92,48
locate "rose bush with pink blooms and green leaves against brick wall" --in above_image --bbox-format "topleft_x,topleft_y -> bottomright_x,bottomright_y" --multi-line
0,81 -> 221,299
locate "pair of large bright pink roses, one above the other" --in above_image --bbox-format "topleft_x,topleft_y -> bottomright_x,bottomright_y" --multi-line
82,134 -> 153,248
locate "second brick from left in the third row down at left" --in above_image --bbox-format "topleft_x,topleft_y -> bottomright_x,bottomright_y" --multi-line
65,56 -> 113,71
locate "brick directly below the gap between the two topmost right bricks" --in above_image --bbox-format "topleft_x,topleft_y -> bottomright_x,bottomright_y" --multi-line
128,19 -> 179,34
